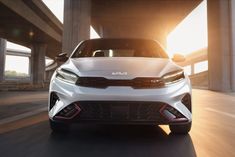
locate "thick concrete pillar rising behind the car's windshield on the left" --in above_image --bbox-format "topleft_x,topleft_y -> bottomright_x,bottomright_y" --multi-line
62,0 -> 91,54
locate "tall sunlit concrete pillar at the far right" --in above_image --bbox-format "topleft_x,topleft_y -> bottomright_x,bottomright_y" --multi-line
207,0 -> 231,92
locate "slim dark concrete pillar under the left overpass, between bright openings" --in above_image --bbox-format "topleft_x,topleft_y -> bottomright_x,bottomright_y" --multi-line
31,43 -> 47,84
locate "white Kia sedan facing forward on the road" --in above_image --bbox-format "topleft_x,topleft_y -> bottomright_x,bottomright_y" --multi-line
49,39 -> 192,133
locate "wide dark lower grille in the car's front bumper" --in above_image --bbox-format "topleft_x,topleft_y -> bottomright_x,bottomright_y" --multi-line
77,101 -> 166,123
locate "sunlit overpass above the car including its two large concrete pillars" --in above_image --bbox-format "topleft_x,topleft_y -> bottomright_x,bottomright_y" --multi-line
62,0 -> 235,92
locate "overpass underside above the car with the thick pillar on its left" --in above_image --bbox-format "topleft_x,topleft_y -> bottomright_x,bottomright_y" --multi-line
63,0 -> 201,53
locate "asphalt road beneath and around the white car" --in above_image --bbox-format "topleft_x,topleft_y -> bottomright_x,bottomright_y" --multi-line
0,89 -> 235,157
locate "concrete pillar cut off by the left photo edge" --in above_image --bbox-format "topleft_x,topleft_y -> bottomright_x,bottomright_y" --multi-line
0,38 -> 7,82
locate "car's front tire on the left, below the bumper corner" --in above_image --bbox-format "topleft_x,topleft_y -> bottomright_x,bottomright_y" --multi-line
49,120 -> 69,133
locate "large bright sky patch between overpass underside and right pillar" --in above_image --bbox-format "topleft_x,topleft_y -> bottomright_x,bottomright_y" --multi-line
167,1 -> 208,55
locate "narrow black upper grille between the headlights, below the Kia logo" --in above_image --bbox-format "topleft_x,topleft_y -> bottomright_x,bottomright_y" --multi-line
76,77 -> 164,88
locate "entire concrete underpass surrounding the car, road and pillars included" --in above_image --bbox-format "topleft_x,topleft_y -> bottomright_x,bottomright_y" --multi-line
0,0 -> 235,157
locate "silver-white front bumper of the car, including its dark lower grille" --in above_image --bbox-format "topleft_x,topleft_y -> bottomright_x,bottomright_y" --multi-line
49,78 -> 192,124
